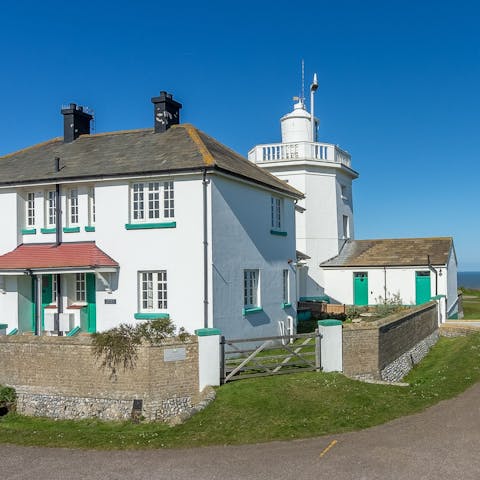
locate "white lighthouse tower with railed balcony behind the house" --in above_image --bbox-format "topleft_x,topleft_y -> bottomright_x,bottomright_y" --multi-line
248,75 -> 358,297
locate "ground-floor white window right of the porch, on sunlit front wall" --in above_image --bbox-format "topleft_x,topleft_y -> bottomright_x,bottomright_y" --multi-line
138,270 -> 168,313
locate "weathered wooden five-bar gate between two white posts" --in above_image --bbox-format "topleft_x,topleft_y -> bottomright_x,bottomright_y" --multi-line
220,330 -> 321,384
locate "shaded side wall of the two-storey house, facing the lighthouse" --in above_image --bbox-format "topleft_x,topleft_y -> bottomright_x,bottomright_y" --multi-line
211,177 -> 296,338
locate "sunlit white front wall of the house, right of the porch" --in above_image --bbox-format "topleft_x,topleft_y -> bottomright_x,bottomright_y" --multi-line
92,177 -> 203,333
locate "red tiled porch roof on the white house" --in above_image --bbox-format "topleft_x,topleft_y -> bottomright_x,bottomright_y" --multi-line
0,242 -> 119,270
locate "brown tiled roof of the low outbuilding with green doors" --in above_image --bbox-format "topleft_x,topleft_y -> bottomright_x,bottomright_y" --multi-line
320,237 -> 453,268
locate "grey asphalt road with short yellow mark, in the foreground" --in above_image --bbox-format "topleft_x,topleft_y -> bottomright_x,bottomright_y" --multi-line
0,383 -> 480,480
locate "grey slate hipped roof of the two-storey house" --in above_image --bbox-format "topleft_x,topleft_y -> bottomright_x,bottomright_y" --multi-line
0,124 -> 303,198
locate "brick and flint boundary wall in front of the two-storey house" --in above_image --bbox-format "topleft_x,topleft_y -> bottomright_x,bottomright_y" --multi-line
0,336 -> 202,421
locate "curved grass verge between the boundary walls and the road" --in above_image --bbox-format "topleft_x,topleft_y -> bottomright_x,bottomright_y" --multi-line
0,334 -> 480,449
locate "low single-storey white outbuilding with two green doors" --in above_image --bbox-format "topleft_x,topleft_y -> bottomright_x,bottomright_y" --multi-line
321,237 -> 458,317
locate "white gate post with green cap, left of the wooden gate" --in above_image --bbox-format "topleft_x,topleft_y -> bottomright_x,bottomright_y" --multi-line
195,328 -> 221,391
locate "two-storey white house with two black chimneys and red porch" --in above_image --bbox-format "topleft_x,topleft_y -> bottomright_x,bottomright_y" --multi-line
0,92 -> 302,337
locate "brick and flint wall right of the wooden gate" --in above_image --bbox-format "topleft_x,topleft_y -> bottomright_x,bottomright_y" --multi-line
343,302 -> 438,381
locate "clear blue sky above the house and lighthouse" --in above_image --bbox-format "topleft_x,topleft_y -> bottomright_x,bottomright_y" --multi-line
0,0 -> 480,270
